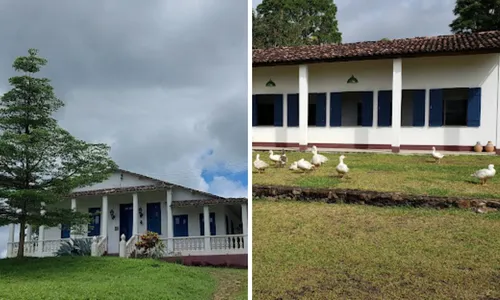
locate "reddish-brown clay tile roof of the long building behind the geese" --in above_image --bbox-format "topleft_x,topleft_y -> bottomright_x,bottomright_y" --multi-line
253,31 -> 500,67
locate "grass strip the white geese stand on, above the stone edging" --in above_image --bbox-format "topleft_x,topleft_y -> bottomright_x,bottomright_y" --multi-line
252,152 -> 500,198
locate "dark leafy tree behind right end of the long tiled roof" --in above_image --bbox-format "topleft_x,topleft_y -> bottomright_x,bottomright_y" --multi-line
450,0 -> 500,33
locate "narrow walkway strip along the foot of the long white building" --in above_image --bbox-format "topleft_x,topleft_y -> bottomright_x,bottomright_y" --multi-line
252,147 -> 495,155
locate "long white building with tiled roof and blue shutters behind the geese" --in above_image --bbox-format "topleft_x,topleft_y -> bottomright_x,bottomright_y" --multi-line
252,31 -> 500,154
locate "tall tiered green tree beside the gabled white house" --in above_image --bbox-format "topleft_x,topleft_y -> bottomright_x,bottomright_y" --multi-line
0,49 -> 117,257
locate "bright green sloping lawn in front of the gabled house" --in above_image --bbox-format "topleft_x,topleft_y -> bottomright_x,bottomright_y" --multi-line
0,257 -> 247,300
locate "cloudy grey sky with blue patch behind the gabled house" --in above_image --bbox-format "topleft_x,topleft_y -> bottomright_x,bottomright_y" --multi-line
0,0 -> 248,253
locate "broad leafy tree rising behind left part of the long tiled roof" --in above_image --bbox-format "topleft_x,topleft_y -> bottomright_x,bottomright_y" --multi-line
252,0 -> 342,48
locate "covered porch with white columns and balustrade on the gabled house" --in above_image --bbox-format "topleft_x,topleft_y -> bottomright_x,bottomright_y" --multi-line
7,187 -> 247,257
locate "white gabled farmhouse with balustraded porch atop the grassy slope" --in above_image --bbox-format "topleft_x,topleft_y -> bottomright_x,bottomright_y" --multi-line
7,170 -> 248,267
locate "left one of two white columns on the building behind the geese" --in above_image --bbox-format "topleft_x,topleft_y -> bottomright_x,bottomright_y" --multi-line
299,65 -> 309,150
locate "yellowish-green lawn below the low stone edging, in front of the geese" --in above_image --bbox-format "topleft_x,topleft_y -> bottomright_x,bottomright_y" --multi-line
252,199 -> 500,299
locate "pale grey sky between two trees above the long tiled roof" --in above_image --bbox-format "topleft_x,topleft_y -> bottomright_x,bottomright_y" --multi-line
252,0 -> 455,43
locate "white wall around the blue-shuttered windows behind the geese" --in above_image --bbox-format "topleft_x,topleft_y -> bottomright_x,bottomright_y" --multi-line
252,54 -> 500,146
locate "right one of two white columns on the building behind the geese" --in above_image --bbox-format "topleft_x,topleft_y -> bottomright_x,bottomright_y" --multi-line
392,58 -> 403,153
